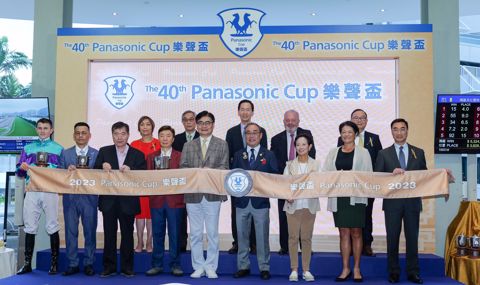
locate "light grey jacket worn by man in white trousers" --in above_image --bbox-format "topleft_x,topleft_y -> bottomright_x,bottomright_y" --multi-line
180,136 -> 229,203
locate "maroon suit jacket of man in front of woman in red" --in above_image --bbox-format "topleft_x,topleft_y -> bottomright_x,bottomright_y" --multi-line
147,149 -> 185,206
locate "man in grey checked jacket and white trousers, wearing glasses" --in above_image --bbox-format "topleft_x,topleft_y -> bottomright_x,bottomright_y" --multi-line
180,111 -> 229,278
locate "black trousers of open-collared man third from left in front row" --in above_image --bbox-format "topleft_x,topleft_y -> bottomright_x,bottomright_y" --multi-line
102,205 -> 135,272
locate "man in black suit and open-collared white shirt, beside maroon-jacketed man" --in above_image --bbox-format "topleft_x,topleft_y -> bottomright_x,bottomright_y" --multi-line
95,122 -> 147,277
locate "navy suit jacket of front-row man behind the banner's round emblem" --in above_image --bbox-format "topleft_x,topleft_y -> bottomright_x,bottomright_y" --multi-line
232,146 -> 278,209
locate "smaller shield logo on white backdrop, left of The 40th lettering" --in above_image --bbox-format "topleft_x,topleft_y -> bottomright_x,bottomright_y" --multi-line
103,75 -> 136,109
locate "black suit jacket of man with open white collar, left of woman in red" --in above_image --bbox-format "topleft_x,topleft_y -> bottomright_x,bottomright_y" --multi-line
94,145 -> 147,215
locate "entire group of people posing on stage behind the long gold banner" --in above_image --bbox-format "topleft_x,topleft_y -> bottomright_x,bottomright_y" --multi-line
17,100 -> 434,284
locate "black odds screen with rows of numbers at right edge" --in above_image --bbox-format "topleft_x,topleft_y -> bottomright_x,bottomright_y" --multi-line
435,94 -> 480,153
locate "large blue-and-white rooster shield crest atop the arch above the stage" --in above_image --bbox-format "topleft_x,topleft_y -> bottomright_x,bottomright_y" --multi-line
217,8 -> 265,57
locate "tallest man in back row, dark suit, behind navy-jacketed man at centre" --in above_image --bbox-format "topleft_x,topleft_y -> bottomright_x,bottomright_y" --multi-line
225,100 -> 267,254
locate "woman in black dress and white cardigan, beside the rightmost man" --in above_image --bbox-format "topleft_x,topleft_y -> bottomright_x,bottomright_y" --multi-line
323,121 -> 372,282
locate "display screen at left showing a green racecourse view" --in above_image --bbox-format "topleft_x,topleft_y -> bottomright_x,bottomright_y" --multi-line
0,97 -> 49,153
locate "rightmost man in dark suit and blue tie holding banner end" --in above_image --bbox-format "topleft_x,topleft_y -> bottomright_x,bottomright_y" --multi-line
375,118 -> 427,284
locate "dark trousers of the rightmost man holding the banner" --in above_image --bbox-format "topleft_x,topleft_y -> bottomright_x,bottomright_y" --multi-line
384,205 -> 420,275
